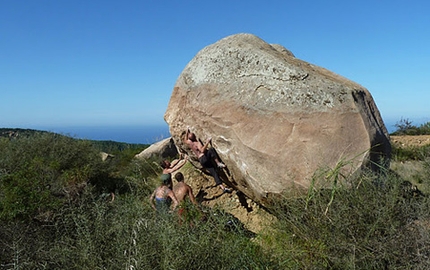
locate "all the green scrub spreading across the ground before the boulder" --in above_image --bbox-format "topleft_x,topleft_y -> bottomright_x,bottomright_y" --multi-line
0,127 -> 430,269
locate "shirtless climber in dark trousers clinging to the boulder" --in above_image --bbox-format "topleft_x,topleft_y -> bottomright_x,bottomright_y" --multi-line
185,129 -> 231,192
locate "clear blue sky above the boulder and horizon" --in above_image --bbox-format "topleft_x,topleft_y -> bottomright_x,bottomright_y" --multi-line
0,0 -> 430,137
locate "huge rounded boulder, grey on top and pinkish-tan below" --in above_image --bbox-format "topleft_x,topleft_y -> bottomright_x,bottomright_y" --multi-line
164,34 -> 391,202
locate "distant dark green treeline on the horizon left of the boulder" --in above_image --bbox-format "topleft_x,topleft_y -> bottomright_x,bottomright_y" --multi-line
0,128 -> 149,153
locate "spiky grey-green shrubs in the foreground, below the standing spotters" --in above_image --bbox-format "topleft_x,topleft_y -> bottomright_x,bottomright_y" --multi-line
0,189 -> 276,269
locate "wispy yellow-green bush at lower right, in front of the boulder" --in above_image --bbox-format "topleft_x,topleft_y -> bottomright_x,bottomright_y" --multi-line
266,169 -> 430,269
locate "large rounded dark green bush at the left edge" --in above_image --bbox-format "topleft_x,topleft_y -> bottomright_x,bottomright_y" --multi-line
0,133 -> 104,219
